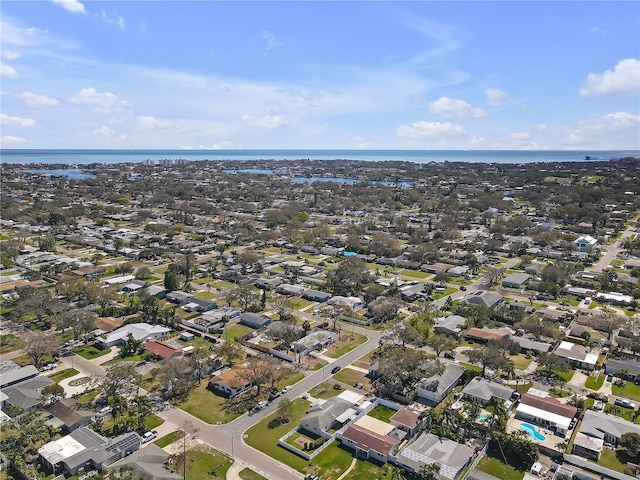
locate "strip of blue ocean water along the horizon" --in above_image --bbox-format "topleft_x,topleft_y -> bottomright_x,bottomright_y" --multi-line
0,149 -> 640,165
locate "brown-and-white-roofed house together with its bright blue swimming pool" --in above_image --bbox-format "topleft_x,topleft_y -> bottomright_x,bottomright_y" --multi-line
515,393 -> 578,441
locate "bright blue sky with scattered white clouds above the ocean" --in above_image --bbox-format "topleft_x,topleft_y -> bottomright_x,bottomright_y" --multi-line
0,0 -> 640,150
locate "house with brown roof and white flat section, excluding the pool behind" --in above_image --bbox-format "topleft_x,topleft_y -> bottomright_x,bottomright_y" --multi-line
516,393 -> 578,436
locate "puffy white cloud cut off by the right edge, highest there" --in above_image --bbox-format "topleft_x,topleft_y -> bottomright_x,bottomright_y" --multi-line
580,58 -> 640,97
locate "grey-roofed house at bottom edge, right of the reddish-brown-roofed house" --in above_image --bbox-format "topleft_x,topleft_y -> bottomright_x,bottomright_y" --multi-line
397,433 -> 473,480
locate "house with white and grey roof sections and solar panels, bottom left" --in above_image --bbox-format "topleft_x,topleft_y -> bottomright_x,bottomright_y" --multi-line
38,427 -> 142,475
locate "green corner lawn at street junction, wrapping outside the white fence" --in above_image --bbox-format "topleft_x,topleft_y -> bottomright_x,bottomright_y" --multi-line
245,398 -> 309,472
